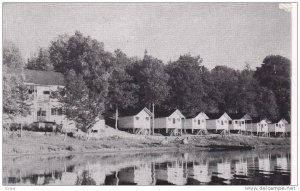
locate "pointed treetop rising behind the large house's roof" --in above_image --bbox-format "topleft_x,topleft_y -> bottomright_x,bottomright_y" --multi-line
26,48 -> 53,71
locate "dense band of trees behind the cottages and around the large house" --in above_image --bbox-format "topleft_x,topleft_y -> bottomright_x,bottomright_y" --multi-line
3,32 -> 291,131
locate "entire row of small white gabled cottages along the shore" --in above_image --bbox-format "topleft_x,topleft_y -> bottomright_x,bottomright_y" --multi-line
118,108 -> 290,134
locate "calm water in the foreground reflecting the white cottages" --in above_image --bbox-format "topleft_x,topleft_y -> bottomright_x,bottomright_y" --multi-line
3,149 -> 291,185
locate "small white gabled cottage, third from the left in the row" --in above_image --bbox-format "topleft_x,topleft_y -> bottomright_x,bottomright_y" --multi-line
184,112 -> 209,133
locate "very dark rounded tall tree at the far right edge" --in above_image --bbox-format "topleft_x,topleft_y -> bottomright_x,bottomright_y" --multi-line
254,55 -> 291,121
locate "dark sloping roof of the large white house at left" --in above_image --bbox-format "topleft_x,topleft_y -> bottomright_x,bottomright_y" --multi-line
24,69 -> 64,86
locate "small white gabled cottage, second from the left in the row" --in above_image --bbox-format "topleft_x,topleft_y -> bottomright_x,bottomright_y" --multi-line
154,109 -> 185,134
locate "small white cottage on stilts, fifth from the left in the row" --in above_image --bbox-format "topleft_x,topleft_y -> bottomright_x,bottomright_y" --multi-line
229,113 -> 252,133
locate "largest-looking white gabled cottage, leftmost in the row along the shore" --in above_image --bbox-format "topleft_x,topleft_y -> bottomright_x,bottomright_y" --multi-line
118,107 -> 153,133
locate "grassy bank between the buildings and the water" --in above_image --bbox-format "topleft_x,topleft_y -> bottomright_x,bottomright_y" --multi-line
3,131 -> 290,155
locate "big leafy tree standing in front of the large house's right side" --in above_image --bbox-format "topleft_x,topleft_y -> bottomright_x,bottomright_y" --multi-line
49,31 -> 110,132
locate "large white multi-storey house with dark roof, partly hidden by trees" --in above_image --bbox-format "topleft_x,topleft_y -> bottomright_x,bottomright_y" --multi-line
16,69 -> 75,129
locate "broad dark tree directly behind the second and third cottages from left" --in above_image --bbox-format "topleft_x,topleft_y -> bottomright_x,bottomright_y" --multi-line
166,54 -> 209,116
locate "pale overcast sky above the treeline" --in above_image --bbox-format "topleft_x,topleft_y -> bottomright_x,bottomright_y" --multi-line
3,3 -> 291,69
